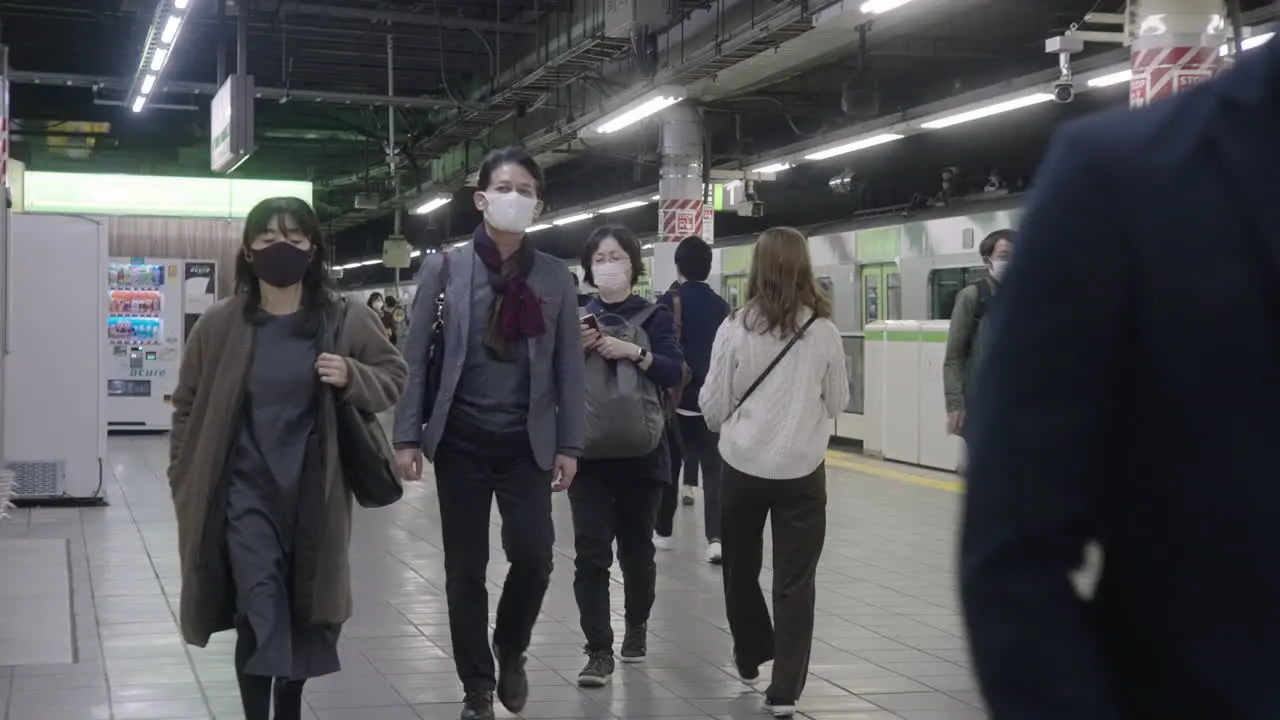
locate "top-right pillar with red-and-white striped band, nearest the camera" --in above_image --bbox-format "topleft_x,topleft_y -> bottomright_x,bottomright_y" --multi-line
1129,0 -> 1229,109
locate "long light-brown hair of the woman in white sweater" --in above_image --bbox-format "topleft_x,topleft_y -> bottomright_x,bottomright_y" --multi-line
742,228 -> 831,336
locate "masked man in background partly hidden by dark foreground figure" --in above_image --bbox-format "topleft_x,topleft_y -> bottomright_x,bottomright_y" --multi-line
942,231 -> 1014,436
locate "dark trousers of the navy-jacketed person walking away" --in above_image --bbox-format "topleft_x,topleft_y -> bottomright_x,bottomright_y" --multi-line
655,415 -> 723,542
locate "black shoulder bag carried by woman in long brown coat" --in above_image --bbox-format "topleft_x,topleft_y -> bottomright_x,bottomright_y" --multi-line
325,299 -> 404,507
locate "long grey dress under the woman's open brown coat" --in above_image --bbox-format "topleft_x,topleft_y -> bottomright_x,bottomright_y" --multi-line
227,314 -> 340,680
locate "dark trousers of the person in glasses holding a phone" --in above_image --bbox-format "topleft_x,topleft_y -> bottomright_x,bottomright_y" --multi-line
568,458 -> 666,651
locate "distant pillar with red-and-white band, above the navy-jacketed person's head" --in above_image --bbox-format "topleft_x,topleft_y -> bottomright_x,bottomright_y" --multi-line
650,102 -> 713,293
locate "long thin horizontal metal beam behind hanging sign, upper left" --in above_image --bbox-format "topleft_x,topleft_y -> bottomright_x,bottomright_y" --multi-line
9,70 -> 456,110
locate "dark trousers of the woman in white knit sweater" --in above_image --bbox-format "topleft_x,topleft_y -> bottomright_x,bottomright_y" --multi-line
722,465 -> 827,701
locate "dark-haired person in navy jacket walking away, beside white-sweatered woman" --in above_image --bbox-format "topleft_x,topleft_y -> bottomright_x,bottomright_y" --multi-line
654,237 -> 730,565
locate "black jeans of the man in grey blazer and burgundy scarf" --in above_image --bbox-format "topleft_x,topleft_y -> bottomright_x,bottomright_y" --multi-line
435,423 -> 556,692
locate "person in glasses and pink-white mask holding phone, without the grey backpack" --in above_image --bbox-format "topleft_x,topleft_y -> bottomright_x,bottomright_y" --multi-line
568,225 -> 684,687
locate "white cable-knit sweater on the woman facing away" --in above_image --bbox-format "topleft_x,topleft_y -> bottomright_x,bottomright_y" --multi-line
698,309 -> 849,480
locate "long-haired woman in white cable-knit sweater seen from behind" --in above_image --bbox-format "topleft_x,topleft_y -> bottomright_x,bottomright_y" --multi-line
698,228 -> 849,717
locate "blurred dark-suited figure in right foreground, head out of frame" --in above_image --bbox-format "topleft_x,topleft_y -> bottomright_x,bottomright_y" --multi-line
961,41 -> 1280,720
